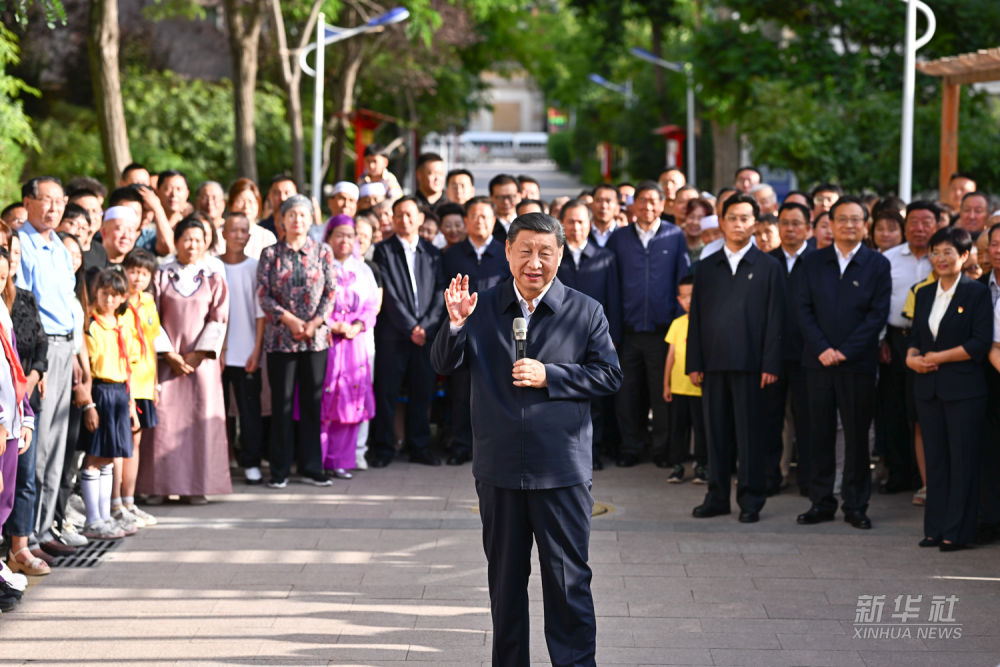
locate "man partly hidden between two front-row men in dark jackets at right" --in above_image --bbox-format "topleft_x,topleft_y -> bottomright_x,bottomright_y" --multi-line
764,202 -> 816,495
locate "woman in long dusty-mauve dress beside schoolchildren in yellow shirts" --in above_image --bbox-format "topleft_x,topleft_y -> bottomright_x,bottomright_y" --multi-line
137,217 -> 232,505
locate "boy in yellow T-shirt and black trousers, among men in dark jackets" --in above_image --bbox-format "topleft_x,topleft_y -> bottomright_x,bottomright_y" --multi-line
663,276 -> 708,484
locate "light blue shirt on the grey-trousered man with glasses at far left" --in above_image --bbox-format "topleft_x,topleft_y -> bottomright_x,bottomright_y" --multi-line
15,221 -> 76,336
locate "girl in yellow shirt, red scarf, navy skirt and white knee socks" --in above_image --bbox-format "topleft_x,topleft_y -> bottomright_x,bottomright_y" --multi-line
80,269 -> 139,540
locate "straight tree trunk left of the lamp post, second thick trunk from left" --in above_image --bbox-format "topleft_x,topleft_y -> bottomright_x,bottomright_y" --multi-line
223,0 -> 265,181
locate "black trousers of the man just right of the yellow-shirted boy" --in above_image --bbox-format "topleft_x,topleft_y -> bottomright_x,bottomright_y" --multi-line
702,371 -> 767,512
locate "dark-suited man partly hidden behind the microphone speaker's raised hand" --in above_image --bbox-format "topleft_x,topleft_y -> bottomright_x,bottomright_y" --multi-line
442,197 -> 510,466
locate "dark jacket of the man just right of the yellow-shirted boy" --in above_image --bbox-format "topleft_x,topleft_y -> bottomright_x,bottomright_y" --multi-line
685,246 -> 785,375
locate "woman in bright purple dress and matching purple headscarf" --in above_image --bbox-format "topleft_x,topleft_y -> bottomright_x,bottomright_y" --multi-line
320,215 -> 378,479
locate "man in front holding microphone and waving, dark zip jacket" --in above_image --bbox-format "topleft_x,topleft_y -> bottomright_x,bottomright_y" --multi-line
432,213 -> 622,666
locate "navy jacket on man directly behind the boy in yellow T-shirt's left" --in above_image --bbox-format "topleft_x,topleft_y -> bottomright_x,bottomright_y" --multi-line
605,222 -> 691,332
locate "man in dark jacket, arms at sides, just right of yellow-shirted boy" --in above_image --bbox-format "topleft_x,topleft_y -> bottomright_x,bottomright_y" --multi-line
681,194 -> 785,523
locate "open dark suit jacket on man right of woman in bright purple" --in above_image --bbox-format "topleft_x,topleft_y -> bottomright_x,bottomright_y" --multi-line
373,236 -> 447,341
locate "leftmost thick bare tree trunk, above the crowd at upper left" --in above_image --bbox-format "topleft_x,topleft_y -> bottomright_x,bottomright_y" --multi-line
87,0 -> 132,186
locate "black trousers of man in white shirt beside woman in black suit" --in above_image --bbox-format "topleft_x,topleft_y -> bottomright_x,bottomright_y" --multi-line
875,327 -> 920,489
